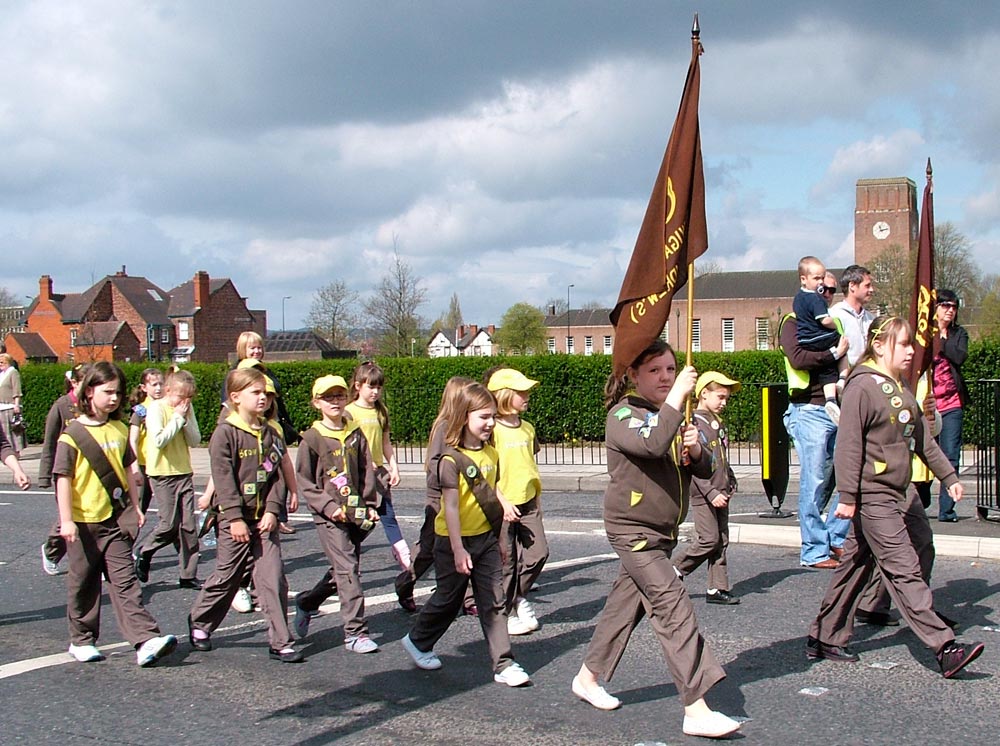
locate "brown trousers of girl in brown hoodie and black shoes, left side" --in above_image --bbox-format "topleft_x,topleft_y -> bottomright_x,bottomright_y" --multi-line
191,522 -> 293,650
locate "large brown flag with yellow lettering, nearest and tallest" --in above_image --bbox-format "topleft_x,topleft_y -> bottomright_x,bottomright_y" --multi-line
611,29 -> 708,377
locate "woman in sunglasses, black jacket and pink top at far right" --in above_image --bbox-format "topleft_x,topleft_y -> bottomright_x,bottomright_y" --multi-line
933,289 -> 971,523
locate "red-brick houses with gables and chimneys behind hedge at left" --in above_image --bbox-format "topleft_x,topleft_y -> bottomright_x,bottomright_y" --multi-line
7,267 -> 267,362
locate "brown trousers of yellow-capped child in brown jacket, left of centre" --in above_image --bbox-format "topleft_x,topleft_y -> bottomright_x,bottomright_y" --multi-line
298,521 -> 376,638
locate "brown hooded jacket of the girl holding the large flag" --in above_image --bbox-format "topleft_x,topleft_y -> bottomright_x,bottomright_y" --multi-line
604,395 -> 712,552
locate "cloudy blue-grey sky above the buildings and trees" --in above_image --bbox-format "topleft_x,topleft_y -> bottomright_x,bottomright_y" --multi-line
0,0 -> 1000,330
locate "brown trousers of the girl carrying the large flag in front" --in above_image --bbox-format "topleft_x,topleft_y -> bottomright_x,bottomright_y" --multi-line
583,547 -> 726,705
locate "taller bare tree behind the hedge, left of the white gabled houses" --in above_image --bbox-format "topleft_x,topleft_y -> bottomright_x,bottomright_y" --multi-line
365,246 -> 427,357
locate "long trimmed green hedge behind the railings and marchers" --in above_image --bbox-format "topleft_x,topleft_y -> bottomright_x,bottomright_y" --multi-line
15,339 -> 1000,443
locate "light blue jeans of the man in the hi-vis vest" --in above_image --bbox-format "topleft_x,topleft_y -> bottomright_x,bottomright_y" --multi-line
784,404 -> 851,565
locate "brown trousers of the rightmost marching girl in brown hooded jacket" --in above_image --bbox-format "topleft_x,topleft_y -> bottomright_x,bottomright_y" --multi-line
809,496 -> 955,653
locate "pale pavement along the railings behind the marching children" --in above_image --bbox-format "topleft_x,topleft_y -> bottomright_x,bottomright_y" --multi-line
7,445 -> 1000,560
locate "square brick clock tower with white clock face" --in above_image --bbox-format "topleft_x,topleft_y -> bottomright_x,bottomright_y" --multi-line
854,177 -> 920,268
